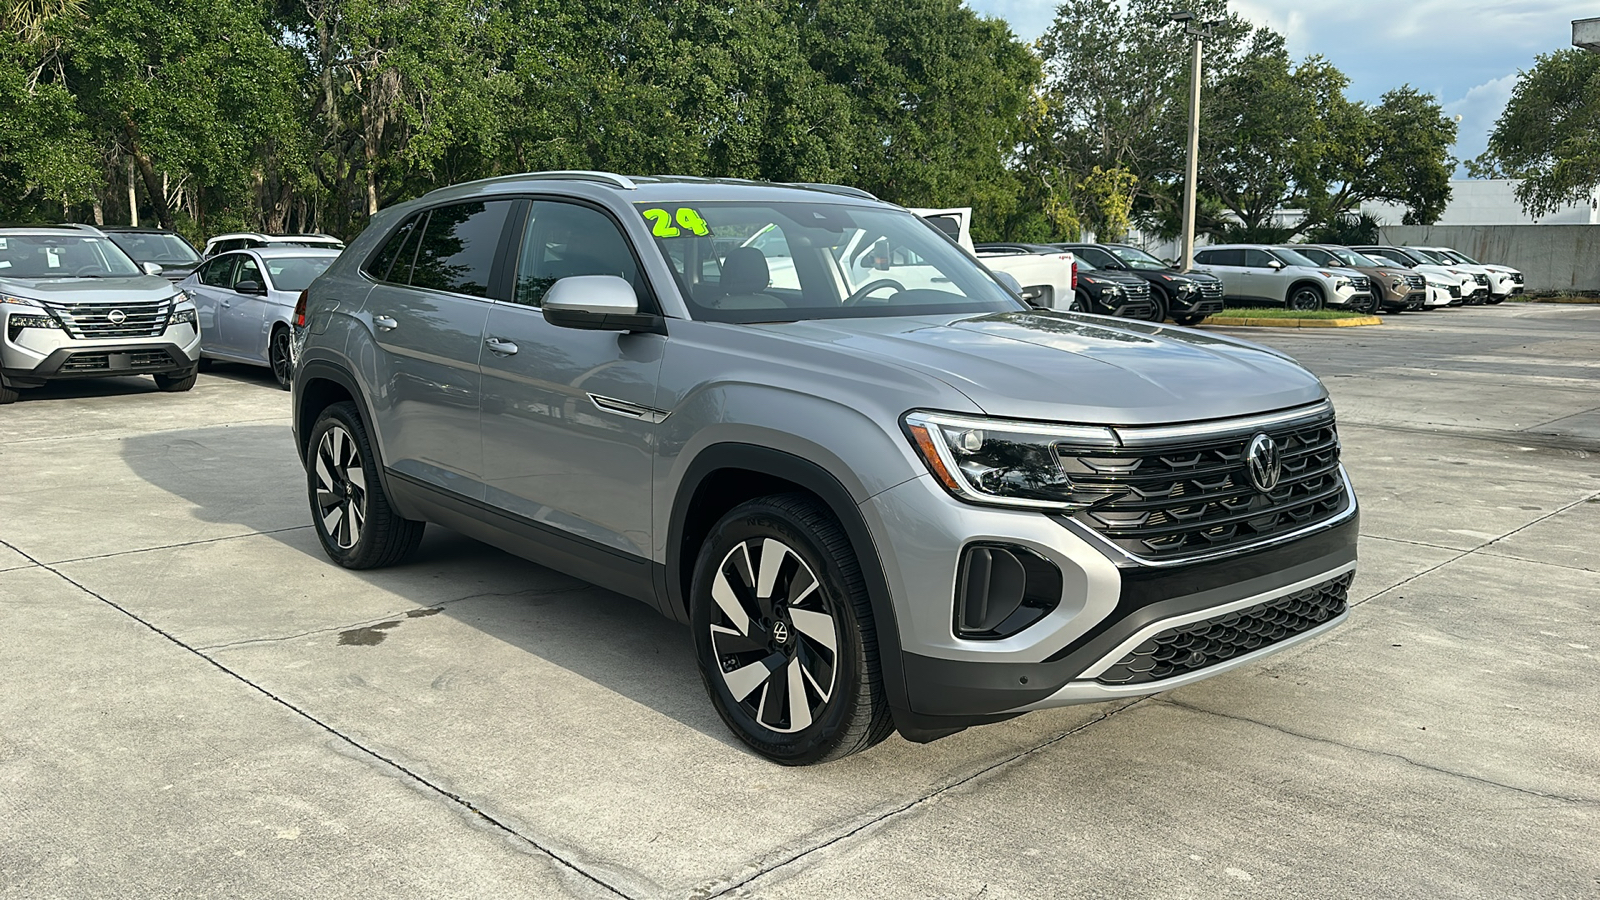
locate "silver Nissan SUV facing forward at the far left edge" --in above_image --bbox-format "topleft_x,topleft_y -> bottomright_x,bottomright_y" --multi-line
0,226 -> 200,404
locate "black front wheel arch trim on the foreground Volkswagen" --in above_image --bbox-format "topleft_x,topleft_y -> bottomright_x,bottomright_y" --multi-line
661,444 -> 909,733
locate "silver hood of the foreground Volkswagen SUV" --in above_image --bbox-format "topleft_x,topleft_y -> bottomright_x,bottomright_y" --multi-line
752,311 -> 1328,424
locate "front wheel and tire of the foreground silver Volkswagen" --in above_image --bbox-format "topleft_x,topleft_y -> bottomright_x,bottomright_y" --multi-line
690,493 -> 894,765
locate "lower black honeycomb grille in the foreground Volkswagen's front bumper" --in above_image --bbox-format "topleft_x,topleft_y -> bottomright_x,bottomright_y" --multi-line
1096,572 -> 1355,684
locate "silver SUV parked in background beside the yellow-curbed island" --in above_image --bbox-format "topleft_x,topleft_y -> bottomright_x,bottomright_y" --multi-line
1195,243 -> 1378,312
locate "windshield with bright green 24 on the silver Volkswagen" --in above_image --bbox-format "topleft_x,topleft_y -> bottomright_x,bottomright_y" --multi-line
638,202 -> 1026,322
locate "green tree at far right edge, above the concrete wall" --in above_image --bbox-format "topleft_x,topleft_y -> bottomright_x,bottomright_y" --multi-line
1467,48 -> 1600,216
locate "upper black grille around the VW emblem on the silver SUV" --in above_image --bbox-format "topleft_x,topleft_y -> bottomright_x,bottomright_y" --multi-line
1061,415 -> 1349,560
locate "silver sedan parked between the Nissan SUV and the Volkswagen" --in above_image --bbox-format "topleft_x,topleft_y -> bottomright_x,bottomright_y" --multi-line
182,247 -> 339,389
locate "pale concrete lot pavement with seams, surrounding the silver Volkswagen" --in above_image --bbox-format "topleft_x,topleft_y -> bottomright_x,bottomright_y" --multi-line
0,304 -> 1600,898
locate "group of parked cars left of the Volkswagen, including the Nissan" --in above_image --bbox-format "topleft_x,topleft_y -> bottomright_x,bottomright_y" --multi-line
0,224 -> 344,404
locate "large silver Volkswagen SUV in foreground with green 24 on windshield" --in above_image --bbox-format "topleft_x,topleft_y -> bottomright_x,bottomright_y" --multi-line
293,173 -> 1357,764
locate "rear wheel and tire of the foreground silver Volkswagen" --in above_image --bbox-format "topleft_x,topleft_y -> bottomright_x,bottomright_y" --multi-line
306,402 -> 427,569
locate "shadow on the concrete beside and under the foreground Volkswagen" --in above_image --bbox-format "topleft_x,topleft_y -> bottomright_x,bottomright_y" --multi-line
122,422 -> 742,749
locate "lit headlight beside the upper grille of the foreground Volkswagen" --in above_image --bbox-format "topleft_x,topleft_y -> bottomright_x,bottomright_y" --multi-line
906,412 -> 1128,509
